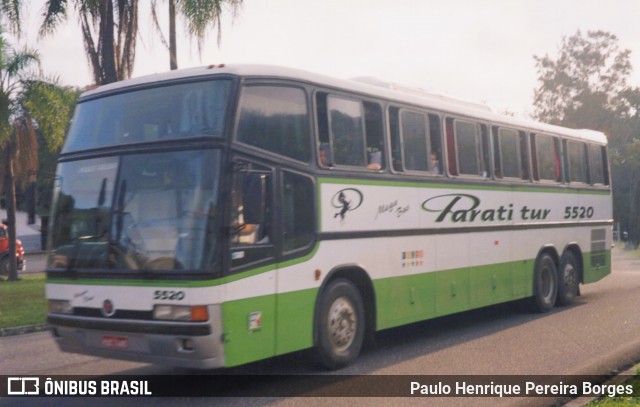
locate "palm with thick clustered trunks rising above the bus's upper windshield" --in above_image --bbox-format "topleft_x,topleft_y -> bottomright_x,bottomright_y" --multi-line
40,0 -> 138,85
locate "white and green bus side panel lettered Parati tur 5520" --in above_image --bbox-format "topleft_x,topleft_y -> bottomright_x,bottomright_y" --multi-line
320,179 -> 610,329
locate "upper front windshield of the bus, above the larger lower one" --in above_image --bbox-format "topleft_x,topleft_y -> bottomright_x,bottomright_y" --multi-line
63,80 -> 231,152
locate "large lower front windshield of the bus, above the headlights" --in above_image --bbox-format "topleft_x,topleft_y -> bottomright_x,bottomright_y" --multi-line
49,150 -> 221,272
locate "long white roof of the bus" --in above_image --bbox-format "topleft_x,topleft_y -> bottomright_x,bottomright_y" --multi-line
81,64 -> 607,144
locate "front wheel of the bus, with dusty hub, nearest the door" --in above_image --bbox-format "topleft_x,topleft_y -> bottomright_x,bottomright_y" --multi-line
316,279 -> 365,370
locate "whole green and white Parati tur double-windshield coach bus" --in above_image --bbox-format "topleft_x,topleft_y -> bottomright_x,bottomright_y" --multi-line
46,65 -> 612,368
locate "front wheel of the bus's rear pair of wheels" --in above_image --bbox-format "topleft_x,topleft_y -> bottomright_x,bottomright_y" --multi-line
530,253 -> 558,313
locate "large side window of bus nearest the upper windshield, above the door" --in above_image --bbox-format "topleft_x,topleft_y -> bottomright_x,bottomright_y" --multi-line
237,86 -> 311,162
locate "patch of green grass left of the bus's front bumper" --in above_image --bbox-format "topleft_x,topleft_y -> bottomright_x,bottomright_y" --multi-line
0,273 -> 47,329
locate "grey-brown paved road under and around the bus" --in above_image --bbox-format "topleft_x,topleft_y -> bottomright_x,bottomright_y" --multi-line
0,251 -> 640,407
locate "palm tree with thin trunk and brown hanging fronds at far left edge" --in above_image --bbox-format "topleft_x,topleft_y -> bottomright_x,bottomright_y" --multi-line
0,35 -> 39,281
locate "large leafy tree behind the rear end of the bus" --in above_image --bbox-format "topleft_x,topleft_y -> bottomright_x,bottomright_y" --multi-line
534,31 -> 640,242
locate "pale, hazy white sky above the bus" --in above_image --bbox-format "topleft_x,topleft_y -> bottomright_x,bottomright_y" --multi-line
16,0 -> 640,116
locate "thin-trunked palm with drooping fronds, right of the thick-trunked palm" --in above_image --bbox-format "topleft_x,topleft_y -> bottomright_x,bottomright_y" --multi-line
151,0 -> 242,70
